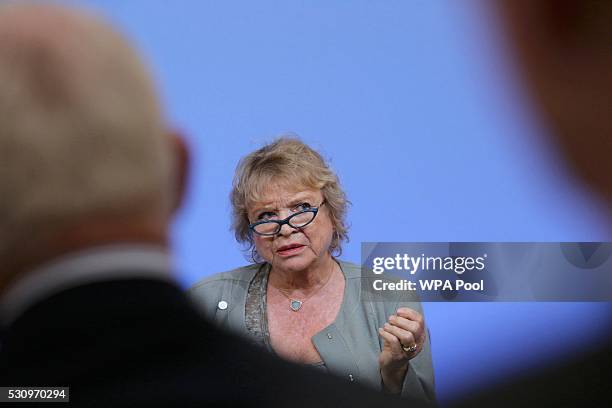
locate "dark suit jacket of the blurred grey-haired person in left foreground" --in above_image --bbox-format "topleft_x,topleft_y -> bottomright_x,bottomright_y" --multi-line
0,280 -> 426,408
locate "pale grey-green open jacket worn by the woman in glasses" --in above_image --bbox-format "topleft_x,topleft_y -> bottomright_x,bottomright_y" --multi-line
189,261 -> 435,402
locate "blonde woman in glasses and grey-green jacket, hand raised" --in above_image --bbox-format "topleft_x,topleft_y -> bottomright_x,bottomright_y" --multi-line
191,138 -> 434,401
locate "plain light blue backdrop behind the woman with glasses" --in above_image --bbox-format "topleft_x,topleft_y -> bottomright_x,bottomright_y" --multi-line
73,0 -> 610,402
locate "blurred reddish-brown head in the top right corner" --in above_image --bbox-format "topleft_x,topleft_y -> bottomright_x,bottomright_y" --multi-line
500,0 -> 612,203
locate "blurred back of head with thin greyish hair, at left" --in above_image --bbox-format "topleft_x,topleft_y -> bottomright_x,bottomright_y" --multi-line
0,5 -> 186,283
